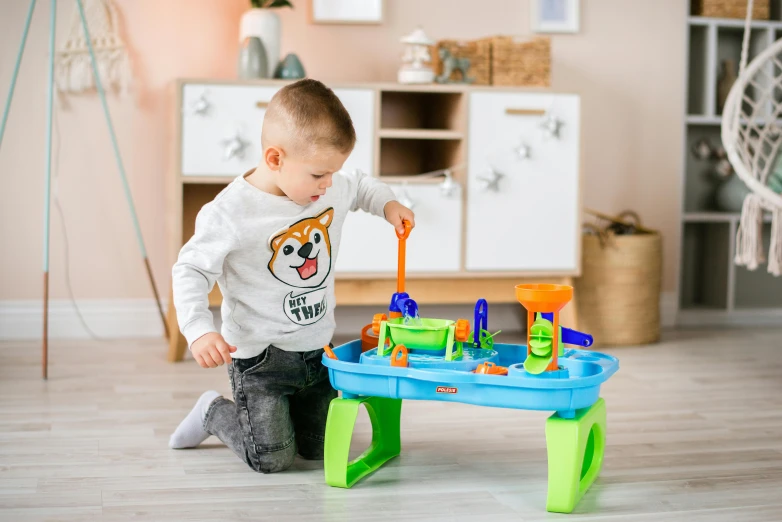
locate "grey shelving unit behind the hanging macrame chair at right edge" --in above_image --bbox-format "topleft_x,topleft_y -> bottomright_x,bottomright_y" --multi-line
677,4 -> 782,325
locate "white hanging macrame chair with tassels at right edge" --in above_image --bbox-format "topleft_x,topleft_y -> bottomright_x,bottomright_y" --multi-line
721,0 -> 782,276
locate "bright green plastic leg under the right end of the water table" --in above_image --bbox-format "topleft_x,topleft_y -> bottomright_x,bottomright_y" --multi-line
546,398 -> 606,513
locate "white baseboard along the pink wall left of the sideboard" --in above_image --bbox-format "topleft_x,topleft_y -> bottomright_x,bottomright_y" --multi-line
0,299 -> 167,340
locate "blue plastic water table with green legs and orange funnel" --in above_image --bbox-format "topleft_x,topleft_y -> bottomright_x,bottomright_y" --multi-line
323,219 -> 619,513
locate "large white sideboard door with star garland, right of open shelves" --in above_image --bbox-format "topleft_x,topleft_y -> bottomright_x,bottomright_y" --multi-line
465,92 -> 580,272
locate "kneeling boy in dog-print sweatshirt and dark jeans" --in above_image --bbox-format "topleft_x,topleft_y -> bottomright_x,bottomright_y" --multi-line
169,79 -> 414,473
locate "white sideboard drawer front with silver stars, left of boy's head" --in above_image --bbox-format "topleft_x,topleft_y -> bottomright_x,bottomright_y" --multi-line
181,84 -> 279,176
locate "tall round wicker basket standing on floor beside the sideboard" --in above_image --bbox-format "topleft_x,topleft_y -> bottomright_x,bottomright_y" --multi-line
574,212 -> 662,346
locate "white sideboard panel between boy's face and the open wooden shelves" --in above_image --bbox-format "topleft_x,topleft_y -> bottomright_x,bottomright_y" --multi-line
334,89 -> 375,174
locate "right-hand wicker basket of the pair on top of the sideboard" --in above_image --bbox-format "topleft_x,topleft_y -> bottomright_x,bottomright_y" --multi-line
491,36 -> 551,87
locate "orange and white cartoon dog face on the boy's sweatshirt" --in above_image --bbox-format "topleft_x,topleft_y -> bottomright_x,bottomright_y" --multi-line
269,208 -> 334,288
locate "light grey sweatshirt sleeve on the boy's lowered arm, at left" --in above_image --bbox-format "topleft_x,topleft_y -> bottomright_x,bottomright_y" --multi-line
171,204 -> 235,346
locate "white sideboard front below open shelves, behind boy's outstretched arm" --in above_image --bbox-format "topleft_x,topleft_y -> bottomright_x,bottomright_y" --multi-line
336,184 -> 462,273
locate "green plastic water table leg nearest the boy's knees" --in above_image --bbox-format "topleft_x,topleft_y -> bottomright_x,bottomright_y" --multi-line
323,397 -> 402,488
